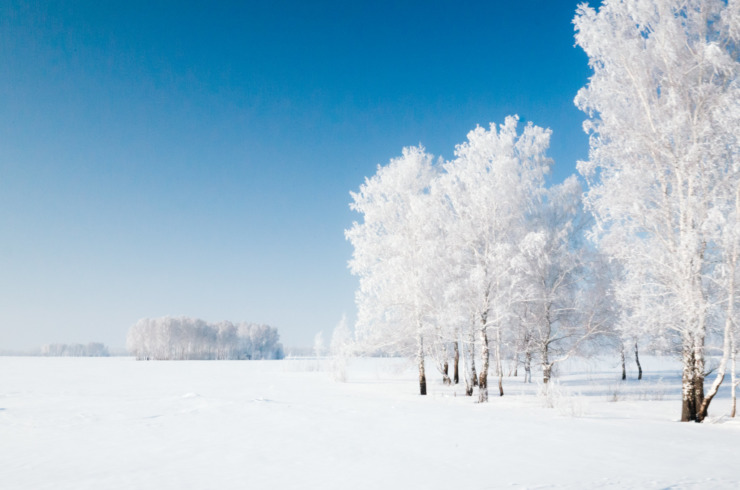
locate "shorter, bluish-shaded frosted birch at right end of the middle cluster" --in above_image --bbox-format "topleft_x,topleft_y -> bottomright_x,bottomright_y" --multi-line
514,176 -> 611,383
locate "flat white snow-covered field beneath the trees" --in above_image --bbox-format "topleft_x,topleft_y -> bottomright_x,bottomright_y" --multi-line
0,357 -> 740,489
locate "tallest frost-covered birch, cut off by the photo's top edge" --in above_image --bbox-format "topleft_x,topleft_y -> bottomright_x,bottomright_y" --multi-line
575,0 -> 740,421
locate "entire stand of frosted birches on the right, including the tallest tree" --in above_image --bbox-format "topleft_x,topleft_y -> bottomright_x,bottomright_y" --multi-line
346,0 -> 740,422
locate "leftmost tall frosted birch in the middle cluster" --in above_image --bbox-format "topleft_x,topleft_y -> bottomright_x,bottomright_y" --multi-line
346,147 -> 439,395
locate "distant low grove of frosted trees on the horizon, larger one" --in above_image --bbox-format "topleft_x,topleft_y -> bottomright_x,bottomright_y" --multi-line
126,316 -> 284,360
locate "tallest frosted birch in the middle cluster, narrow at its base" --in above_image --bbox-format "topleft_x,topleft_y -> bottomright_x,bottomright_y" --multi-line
442,116 -> 550,402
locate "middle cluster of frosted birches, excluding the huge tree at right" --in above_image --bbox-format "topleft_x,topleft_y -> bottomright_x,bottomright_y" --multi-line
346,116 -> 614,402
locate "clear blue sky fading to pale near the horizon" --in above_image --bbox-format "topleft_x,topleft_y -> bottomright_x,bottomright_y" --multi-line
0,0 -> 590,350
